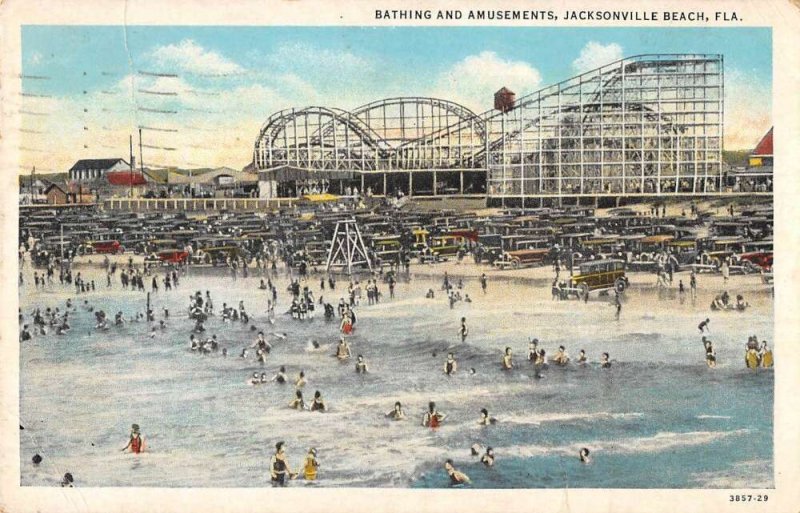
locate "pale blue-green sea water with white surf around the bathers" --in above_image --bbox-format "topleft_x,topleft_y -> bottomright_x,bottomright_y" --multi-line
20,269 -> 780,488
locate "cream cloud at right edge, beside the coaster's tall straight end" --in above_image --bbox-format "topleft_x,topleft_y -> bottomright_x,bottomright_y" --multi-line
725,68 -> 772,150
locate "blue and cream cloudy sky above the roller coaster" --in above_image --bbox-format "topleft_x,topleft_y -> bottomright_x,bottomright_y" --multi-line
15,26 -> 772,173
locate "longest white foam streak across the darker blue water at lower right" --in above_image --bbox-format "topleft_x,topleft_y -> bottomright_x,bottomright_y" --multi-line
506,429 -> 750,457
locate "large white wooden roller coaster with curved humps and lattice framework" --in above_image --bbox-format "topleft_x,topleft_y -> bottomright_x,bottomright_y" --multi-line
253,54 -> 731,206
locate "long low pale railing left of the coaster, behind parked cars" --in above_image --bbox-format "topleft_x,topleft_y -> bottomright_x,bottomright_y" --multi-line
103,198 -> 297,212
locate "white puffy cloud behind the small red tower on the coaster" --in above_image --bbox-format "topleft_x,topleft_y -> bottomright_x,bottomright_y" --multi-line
435,51 -> 542,113
